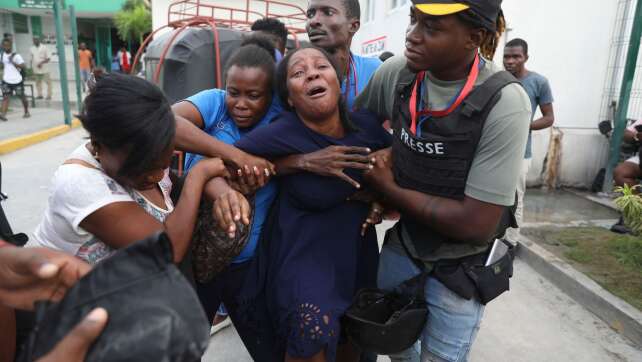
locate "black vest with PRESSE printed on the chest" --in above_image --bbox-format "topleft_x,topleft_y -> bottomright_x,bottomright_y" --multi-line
392,70 -> 519,257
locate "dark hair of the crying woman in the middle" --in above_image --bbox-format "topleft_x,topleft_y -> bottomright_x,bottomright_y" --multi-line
276,45 -> 357,132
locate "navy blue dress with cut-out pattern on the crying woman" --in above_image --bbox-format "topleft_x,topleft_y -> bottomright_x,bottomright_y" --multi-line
236,112 -> 390,361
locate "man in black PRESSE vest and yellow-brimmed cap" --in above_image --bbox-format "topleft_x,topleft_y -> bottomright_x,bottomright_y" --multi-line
356,0 -> 531,362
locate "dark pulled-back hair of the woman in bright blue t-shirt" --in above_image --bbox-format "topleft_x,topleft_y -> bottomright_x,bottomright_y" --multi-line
224,35 -> 276,91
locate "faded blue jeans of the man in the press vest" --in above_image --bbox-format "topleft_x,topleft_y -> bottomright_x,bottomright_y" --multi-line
377,246 -> 484,362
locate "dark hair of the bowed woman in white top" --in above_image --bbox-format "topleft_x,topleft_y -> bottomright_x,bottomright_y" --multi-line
78,73 -> 176,177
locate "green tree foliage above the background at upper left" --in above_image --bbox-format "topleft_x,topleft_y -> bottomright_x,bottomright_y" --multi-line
114,0 -> 152,44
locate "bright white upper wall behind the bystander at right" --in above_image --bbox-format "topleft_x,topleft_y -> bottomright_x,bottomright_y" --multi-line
495,0 -> 617,128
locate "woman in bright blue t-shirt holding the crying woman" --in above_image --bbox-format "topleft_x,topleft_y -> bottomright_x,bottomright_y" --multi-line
172,38 -> 281,350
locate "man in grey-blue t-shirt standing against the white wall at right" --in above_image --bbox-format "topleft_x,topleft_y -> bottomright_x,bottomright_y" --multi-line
504,38 -> 555,242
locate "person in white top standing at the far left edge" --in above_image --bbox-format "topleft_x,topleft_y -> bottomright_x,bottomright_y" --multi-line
0,38 -> 31,122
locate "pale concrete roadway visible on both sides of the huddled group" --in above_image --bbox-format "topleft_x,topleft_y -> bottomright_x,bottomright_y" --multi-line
0,130 -> 642,362
